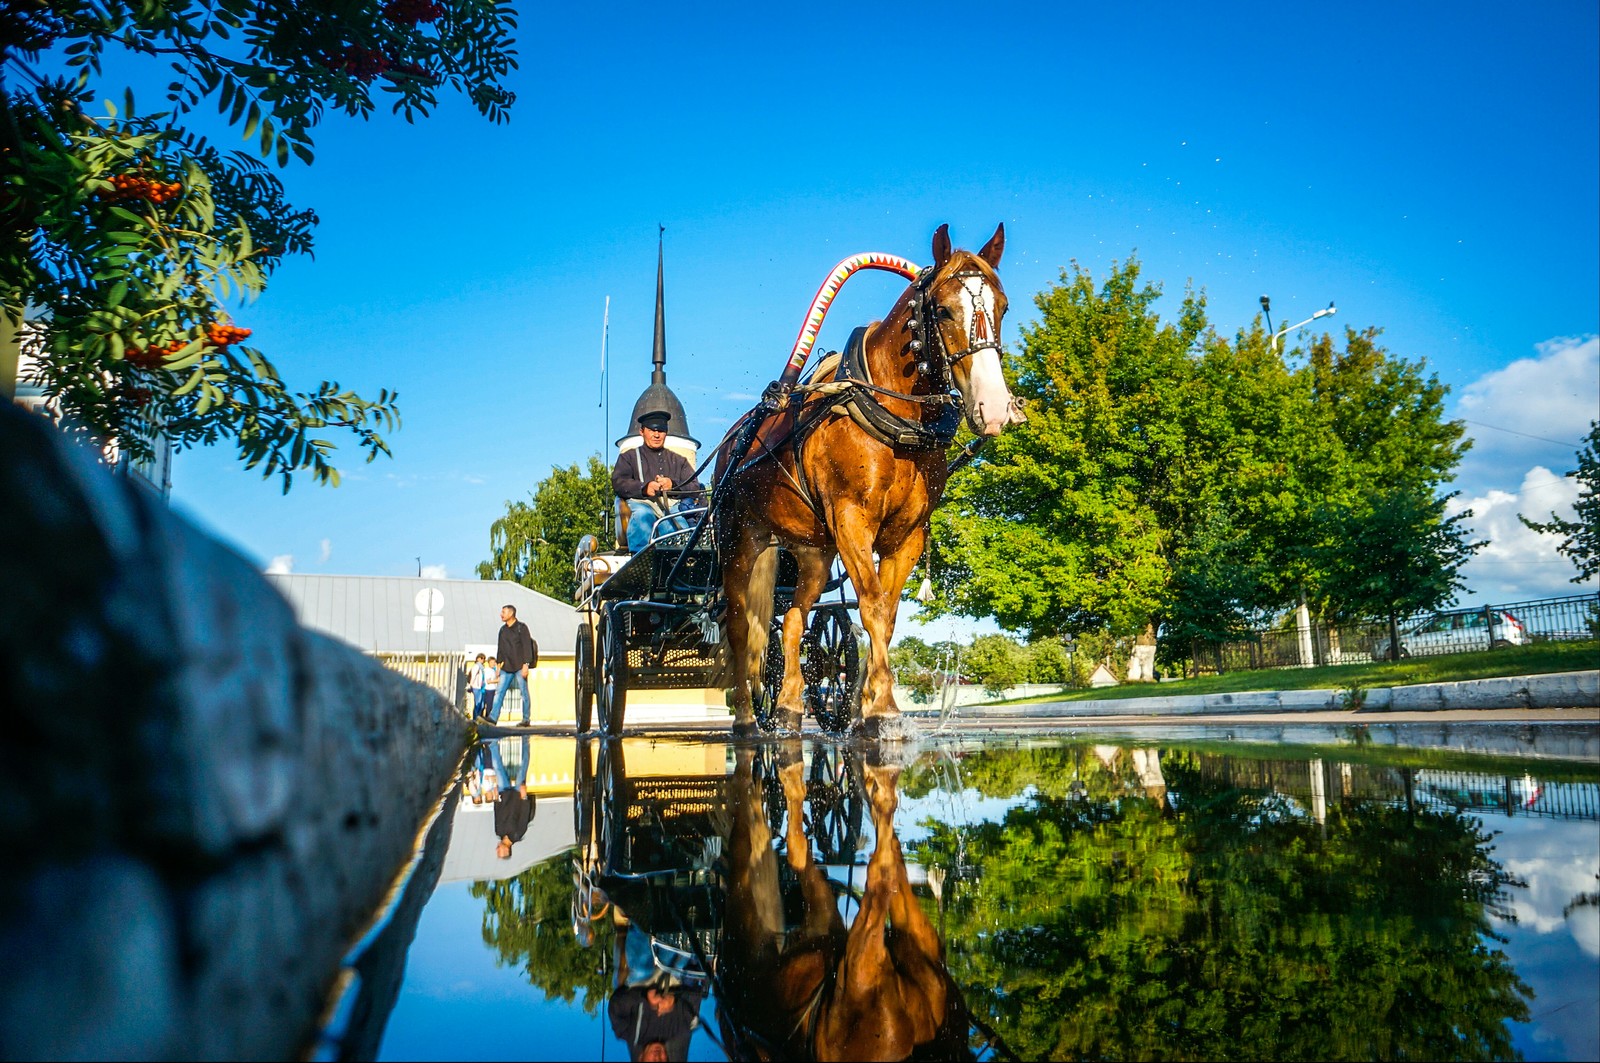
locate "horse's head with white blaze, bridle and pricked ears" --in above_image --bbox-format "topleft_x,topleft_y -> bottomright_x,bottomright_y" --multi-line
910,224 -> 1027,435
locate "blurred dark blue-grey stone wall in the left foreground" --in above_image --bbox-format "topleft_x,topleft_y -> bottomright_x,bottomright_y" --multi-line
0,405 -> 467,1058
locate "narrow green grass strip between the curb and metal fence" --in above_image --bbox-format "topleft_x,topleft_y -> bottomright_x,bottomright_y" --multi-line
990,640 -> 1600,704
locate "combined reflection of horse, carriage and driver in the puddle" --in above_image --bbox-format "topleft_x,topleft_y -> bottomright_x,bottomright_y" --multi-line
574,740 -> 974,1060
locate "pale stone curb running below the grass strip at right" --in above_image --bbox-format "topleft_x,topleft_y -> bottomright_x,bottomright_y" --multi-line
960,671 -> 1600,720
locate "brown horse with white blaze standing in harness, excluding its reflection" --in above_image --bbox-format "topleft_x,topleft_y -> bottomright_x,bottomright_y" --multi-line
717,226 -> 1024,733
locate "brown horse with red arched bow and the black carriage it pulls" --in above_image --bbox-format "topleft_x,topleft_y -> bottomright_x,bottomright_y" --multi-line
574,226 -> 1026,736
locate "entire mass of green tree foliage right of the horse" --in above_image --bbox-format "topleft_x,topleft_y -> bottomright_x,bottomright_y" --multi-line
931,261 -> 1466,647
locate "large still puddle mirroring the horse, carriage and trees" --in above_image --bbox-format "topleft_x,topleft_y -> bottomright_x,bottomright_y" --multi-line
363,728 -> 1600,1060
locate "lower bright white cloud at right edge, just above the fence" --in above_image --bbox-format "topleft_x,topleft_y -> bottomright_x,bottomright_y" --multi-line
1450,466 -> 1592,602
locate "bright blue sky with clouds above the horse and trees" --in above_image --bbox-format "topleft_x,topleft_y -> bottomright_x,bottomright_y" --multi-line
78,0 -> 1600,614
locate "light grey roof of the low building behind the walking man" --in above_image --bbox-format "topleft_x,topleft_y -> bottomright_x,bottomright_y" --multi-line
267,573 -> 578,656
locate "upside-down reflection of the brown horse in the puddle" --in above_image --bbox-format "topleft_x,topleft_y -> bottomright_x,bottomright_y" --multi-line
717,740 -> 973,1060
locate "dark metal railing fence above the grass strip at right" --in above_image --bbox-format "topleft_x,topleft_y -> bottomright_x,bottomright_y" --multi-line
1190,594 -> 1600,674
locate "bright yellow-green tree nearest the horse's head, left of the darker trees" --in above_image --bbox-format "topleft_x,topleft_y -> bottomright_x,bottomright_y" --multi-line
933,261 -> 1205,637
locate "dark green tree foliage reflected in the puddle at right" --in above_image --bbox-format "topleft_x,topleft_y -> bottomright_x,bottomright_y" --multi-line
909,748 -> 1530,1060
